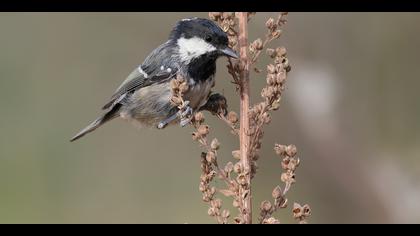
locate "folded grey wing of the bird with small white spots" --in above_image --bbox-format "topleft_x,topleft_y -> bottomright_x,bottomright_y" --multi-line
102,67 -> 177,110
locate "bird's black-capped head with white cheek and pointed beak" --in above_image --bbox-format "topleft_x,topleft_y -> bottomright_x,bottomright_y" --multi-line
169,18 -> 238,62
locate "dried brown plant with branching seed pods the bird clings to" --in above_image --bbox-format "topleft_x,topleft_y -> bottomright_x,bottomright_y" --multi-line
203,12 -> 311,224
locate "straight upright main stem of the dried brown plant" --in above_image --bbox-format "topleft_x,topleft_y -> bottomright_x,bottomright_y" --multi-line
236,12 -> 252,224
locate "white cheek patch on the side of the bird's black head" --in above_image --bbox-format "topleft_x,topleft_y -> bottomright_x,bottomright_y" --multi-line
177,37 -> 216,62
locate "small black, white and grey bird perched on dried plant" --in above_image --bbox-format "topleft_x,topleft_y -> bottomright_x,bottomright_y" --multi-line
70,17 -> 238,142
